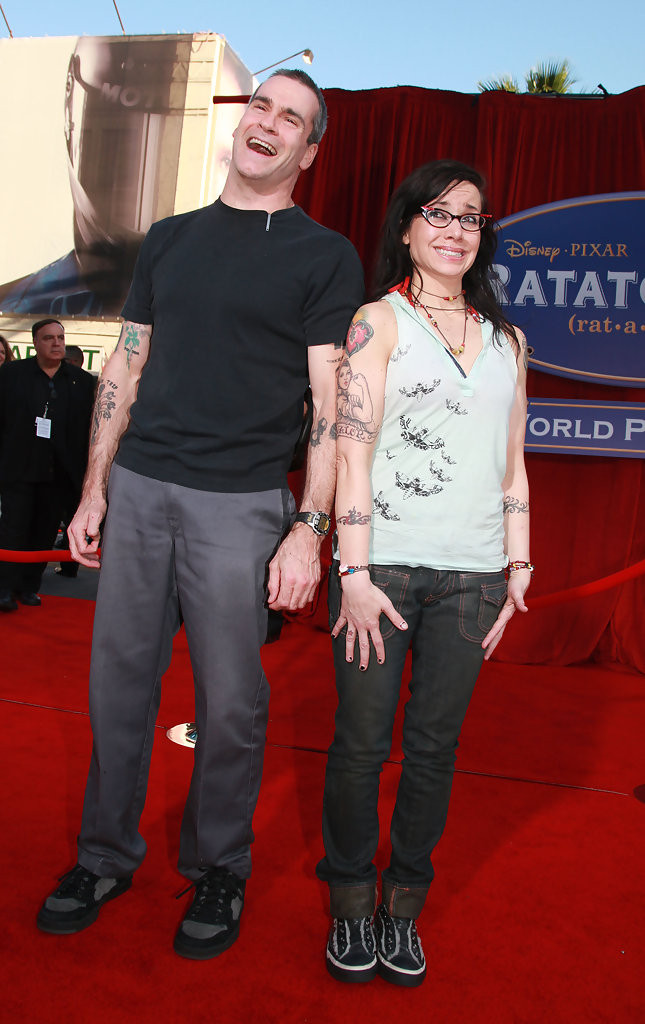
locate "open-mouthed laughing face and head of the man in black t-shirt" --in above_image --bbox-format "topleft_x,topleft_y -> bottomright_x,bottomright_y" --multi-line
231,75 -> 318,190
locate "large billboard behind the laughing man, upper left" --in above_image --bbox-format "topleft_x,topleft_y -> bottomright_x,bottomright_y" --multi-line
0,33 -> 253,323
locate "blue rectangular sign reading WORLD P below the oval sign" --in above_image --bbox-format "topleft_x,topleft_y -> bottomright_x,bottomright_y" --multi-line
524,398 -> 645,459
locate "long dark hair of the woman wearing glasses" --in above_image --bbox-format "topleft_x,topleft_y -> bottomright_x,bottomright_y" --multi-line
372,160 -> 519,353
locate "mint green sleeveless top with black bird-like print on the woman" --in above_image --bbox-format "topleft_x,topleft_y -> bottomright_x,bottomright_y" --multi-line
370,292 -> 517,571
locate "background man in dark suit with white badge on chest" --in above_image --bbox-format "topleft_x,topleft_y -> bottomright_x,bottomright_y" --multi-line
0,318 -> 94,611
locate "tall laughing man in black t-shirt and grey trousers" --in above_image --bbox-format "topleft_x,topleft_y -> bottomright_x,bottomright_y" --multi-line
38,71 -> 362,959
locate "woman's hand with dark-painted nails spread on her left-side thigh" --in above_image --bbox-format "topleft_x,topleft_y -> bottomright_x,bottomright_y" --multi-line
332,572 -> 407,672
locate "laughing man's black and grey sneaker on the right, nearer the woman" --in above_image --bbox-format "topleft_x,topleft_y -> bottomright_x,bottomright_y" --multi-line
174,867 -> 246,959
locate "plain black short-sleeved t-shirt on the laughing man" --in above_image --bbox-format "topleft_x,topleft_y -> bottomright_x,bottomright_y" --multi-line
117,200 -> 363,492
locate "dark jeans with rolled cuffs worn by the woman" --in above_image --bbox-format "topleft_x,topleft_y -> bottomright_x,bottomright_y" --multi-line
316,563 -> 506,916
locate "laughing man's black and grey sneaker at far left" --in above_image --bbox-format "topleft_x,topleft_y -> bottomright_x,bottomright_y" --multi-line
36,864 -> 132,935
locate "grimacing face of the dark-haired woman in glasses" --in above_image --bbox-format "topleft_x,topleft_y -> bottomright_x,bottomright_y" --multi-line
401,181 -> 481,287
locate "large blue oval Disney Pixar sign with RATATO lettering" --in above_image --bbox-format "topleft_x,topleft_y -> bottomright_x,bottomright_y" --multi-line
496,191 -> 645,387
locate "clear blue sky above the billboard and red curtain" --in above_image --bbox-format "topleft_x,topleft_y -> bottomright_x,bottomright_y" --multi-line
0,0 -> 645,92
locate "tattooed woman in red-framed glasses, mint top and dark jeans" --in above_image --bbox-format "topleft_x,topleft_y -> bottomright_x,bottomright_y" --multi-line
317,160 -> 532,986
